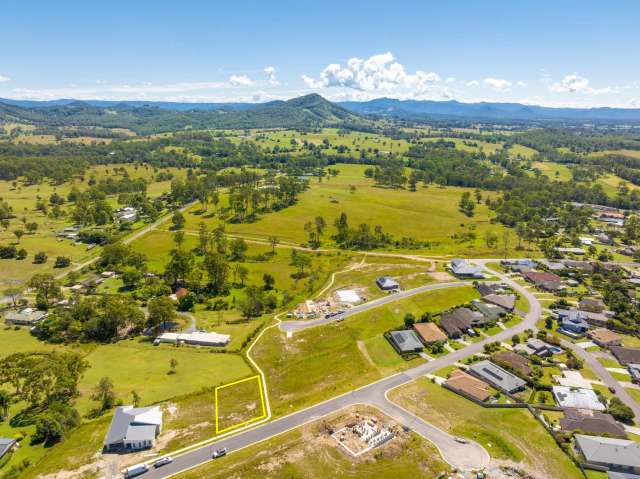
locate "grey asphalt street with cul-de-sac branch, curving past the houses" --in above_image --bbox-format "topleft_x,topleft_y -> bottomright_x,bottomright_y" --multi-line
140,260 -> 542,479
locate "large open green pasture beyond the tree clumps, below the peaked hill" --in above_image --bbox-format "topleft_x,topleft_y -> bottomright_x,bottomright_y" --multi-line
180,165 -> 515,256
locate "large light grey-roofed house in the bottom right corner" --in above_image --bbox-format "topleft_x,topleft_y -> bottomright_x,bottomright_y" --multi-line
575,434 -> 640,473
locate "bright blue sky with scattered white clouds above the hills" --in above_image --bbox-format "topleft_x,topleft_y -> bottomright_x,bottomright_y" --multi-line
0,0 -> 640,108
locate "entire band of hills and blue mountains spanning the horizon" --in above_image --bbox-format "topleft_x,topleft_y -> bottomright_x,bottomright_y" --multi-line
0,94 -> 640,134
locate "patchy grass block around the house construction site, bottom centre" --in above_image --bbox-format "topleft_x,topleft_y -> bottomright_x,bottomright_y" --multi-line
180,408 -> 449,479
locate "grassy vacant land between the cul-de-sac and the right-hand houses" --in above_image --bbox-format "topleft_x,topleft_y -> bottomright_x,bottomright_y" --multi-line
390,379 -> 582,479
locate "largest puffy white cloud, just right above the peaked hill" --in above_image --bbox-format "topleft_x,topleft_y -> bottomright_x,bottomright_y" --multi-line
302,52 -> 440,98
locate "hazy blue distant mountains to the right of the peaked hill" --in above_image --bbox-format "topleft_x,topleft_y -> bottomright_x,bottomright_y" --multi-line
339,98 -> 640,123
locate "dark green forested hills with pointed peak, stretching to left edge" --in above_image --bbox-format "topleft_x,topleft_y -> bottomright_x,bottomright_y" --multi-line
0,95 -> 370,134
